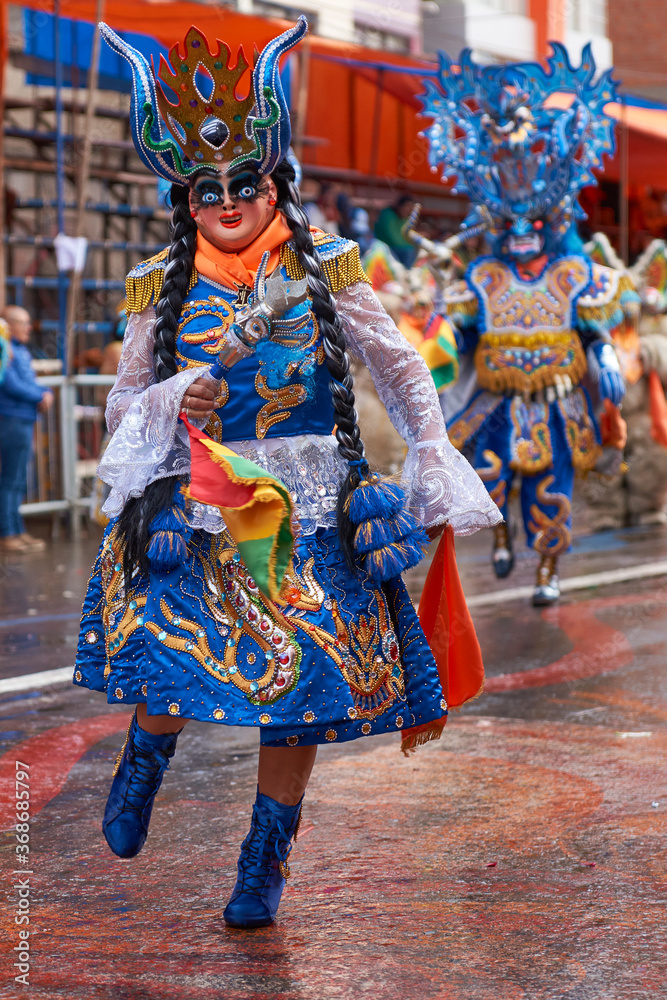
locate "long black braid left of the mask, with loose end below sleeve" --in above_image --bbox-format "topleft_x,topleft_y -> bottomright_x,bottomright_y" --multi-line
116,184 -> 197,589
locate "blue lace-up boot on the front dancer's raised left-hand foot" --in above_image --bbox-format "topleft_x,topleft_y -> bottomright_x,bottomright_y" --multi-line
102,712 -> 178,858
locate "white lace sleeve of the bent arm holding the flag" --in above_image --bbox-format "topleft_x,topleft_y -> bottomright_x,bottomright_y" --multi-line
97,306 -> 207,517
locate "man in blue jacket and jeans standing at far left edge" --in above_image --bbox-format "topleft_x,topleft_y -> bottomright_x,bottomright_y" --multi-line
0,306 -> 53,552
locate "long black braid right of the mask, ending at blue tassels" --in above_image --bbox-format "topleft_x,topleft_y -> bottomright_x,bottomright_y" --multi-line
271,160 -> 368,568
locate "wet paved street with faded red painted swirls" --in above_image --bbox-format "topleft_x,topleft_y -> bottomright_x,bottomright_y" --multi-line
0,516 -> 667,1000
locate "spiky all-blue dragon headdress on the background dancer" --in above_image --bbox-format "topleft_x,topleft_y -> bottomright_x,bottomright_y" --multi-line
421,42 -> 617,238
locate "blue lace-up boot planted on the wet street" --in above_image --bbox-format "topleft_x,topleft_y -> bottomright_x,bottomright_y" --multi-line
223,791 -> 303,928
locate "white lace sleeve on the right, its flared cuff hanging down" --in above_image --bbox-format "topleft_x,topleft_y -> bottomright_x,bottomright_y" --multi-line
335,282 -> 502,535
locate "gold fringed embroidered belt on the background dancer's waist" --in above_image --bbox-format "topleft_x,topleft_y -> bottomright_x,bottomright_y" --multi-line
475,331 -> 586,394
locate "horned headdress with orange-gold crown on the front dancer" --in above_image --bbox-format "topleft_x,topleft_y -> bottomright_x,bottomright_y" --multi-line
100,16 -> 308,184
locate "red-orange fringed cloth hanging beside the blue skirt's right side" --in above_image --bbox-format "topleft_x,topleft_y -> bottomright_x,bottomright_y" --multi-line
401,525 -> 484,754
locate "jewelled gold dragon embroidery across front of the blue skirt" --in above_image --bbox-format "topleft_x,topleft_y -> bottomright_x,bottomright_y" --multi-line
146,533 -> 405,721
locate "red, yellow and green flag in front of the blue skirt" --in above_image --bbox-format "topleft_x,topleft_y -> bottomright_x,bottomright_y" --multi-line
181,414 -> 294,601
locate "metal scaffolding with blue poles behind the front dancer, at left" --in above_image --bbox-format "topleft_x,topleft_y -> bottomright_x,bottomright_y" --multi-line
2,5 -> 167,364
